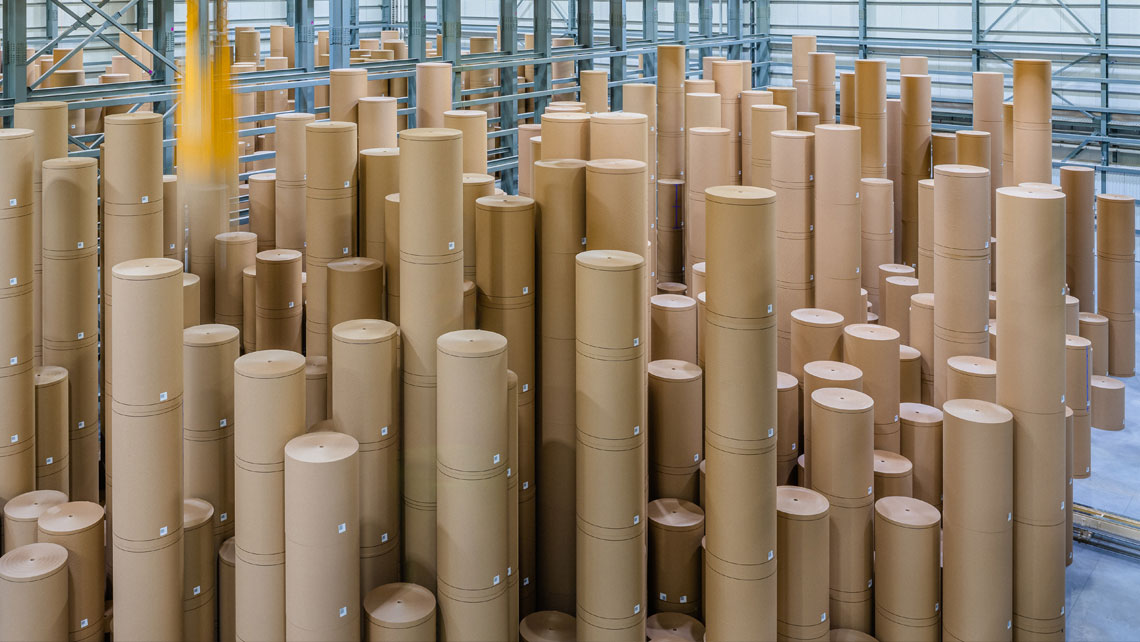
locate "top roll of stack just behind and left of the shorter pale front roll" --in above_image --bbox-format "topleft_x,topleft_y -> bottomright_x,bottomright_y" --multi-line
234,350 -> 304,464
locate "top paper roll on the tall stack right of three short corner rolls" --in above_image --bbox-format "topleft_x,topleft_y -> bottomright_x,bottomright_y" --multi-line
112,259 -> 182,412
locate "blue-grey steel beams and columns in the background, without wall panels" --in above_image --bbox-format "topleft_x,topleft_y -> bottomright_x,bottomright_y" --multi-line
0,0 -> 1140,196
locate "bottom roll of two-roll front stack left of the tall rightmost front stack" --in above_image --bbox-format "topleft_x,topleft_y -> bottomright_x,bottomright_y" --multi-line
942,523 -> 1013,640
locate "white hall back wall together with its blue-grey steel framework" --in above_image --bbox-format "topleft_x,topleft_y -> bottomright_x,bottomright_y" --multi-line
0,0 -> 1140,192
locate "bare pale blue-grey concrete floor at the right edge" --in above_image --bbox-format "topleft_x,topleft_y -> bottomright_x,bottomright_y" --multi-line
1066,258 -> 1140,642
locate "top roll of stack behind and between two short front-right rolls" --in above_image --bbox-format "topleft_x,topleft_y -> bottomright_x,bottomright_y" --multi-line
807,388 -> 874,499
